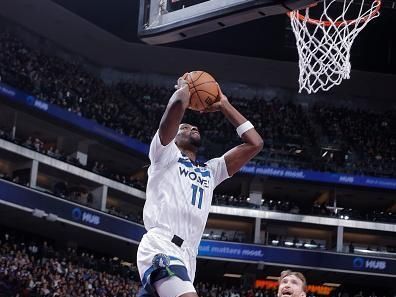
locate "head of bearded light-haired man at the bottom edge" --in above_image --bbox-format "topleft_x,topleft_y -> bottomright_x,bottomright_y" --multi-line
278,270 -> 307,297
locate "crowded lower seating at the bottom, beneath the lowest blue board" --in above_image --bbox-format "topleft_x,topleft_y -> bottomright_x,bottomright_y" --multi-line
0,226 -> 386,297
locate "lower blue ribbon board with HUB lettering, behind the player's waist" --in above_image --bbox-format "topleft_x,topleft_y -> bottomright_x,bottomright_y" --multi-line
0,180 -> 396,277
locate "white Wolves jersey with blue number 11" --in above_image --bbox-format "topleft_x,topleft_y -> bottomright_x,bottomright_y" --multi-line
143,131 -> 229,250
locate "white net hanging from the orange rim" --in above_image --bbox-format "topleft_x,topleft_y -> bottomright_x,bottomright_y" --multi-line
289,0 -> 381,94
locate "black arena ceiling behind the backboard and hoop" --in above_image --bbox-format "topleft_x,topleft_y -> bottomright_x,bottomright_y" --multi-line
53,0 -> 396,74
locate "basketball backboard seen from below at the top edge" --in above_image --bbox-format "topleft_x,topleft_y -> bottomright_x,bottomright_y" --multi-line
138,0 -> 319,44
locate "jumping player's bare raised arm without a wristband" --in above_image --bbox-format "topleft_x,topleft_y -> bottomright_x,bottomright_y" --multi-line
159,77 -> 190,146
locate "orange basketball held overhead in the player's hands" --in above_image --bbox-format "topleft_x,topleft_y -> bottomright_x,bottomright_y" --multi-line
183,71 -> 220,111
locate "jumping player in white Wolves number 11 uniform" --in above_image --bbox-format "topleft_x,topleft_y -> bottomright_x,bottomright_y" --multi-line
137,78 -> 263,297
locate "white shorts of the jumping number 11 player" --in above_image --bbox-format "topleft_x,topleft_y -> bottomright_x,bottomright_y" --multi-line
137,229 -> 196,297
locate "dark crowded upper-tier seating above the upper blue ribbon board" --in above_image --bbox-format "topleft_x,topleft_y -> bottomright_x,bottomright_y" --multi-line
0,33 -> 396,177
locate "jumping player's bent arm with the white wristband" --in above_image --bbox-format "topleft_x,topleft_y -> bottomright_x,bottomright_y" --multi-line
206,86 -> 264,176
